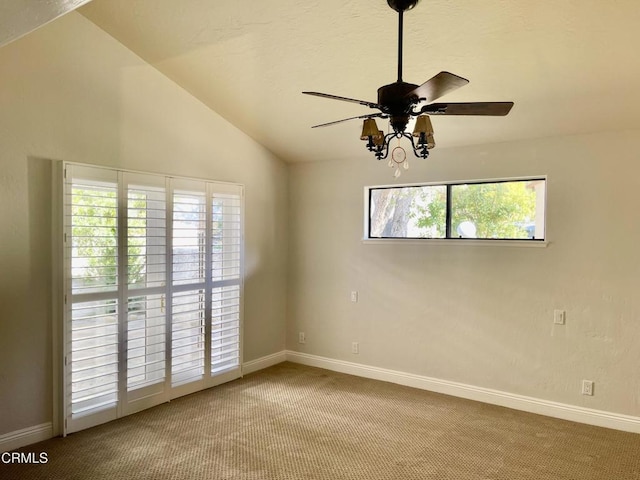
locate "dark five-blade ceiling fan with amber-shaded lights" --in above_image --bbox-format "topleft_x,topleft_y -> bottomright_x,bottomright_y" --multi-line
302,0 -> 513,176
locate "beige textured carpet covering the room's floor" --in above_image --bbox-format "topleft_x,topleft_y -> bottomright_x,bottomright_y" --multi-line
0,363 -> 640,480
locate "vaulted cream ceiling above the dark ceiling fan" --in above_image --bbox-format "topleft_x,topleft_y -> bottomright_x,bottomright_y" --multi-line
72,0 -> 640,162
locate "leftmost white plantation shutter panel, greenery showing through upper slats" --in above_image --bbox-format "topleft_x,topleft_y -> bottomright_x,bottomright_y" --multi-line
64,166 -> 120,429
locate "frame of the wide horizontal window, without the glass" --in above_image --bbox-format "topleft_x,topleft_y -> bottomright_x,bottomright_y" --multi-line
362,175 -> 549,247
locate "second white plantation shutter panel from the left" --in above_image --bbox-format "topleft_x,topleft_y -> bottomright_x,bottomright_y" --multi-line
123,173 -> 167,412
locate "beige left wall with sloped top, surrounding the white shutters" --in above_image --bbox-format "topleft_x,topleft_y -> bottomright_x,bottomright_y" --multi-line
0,13 -> 288,435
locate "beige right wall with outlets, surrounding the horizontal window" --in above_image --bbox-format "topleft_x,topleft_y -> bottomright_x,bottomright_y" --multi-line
287,130 -> 640,416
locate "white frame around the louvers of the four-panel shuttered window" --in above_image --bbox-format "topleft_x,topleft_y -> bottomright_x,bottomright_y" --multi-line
58,161 -> 245,435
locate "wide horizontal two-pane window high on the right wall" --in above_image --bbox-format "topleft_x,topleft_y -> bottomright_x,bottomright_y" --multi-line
366,178 -> 546,241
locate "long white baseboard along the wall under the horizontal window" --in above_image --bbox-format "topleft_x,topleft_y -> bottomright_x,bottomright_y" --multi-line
286,350 -> 640,433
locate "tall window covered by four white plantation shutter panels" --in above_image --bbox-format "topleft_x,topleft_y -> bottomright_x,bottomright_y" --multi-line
64,164 -> 242,432
